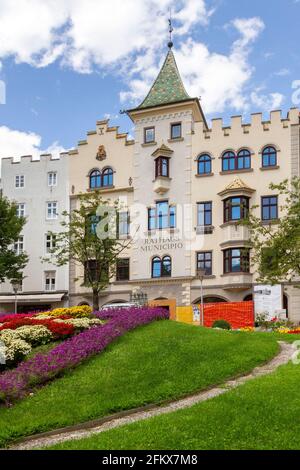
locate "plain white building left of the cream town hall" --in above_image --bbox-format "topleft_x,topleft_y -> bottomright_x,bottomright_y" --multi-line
0,154 -> 69,312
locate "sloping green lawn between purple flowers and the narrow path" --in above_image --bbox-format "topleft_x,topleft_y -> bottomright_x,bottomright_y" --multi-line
0,321 -> 278,447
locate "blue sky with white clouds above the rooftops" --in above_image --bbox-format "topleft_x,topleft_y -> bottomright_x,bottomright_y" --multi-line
0,0 -> 300,161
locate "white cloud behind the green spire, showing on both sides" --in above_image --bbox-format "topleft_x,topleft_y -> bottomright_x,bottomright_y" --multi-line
121,17 -> 264,114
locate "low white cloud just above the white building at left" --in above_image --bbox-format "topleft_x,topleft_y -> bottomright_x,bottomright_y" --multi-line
0,126 -> 65,167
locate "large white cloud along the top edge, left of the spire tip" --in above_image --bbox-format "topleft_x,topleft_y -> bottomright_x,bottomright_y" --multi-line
0,0 -> 212,72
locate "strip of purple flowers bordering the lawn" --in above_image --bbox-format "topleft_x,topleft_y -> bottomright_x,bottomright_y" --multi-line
0,307 -> 169,404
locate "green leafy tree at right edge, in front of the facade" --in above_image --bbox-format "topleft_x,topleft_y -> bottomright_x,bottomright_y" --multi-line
245,178 -> 300,285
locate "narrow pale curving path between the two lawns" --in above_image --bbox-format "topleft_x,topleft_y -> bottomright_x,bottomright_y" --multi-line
10,342 -> 295,450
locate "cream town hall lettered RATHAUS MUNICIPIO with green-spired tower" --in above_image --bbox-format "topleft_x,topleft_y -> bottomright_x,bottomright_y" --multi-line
3,48 -> 300,321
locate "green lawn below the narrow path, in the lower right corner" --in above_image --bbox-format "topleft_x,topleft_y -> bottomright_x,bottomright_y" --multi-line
53,364 -> 300,450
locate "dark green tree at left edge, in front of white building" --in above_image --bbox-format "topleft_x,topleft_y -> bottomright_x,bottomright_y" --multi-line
0,197 -> 28,282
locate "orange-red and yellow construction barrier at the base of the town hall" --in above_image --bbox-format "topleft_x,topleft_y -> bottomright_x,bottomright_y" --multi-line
176,301 -> 254,329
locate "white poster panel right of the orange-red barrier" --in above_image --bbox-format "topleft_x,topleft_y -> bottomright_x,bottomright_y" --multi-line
254,285 -> 282,320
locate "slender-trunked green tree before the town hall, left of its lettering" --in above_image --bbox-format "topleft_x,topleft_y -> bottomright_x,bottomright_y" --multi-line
45,191 -> 131,310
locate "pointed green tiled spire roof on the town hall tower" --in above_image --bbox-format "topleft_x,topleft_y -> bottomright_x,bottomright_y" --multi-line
138,50 -> 191,109
